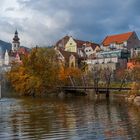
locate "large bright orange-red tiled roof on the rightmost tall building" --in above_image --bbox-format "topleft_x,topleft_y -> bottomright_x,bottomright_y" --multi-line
102,32 -> 134,46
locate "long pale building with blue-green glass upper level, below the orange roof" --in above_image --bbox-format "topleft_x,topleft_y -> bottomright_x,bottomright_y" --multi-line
85,49 -> 130,71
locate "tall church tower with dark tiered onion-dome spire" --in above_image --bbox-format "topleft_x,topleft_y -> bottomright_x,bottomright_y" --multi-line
12,30 -> 20,52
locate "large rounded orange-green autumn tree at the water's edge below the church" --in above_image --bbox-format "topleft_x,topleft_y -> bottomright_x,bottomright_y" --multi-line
7,48 -> 60,96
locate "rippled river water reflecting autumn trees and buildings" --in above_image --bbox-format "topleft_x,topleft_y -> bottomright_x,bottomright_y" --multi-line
0,96 -> 140,140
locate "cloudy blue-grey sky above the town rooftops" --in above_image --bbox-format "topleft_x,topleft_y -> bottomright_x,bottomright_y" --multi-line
0,0 -> 140,47
